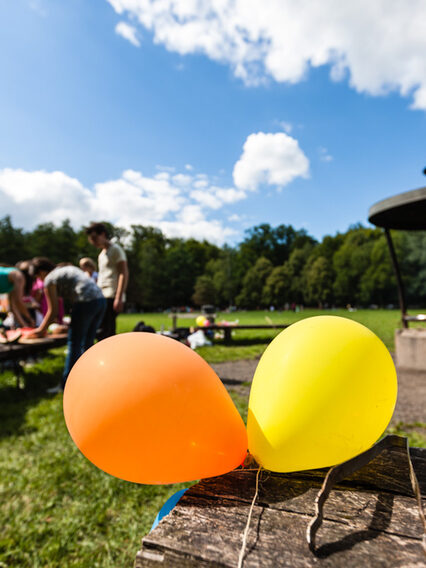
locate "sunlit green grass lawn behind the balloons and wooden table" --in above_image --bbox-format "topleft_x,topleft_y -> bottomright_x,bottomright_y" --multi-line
0,310 -> 426,568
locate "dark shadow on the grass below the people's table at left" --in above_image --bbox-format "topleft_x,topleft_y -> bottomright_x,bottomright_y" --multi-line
0,354 -> 64,439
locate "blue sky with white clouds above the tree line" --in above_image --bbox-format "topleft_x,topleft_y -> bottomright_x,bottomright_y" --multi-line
0,0 -> 426,244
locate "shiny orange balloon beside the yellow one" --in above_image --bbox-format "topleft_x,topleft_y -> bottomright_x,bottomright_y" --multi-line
64,332 -> 247,484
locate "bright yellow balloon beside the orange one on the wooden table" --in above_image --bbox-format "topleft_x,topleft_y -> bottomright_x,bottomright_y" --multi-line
247,316 -> 397,472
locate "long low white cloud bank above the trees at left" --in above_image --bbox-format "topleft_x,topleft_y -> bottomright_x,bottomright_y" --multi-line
0,168 -> 245,244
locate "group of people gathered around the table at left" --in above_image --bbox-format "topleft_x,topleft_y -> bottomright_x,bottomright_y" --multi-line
0,223 -> 129,391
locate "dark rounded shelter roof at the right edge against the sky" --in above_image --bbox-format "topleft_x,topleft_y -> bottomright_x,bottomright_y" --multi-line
368,187 -> 426,231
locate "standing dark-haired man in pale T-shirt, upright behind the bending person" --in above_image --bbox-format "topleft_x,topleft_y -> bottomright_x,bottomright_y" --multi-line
86,223 -> 129,339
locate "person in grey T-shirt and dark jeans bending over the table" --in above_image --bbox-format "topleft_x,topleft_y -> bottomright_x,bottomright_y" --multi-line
27,257 -> 106,393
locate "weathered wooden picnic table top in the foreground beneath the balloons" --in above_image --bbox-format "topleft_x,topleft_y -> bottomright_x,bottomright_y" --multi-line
135,437 -> 426,568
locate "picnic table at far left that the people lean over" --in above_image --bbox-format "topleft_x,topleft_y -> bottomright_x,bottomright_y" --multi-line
0,334 -> 67,388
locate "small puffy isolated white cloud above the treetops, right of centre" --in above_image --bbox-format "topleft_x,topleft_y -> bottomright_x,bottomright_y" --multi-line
233,132 -> 309,191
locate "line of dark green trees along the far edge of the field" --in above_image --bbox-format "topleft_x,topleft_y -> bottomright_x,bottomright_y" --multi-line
0,216 -> 426,311
